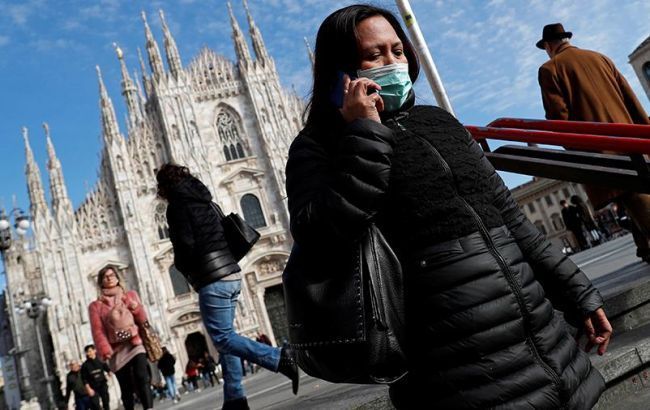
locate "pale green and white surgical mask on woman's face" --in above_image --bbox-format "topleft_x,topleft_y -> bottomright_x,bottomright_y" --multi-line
357,63 -> 413,111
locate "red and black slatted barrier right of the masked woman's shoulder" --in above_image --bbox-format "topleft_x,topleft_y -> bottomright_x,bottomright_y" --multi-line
466,118 -> 650,193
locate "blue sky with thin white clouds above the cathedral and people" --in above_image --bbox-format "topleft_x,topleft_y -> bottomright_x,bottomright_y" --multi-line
0,0 -> 650,286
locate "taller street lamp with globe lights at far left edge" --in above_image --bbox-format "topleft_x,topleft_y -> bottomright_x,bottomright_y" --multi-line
0,207 -> 34,401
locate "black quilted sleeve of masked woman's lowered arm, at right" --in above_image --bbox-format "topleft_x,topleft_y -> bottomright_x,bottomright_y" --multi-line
469,133 -> 603,326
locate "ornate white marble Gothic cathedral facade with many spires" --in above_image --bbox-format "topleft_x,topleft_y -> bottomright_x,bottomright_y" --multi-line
6,2 -> 304,403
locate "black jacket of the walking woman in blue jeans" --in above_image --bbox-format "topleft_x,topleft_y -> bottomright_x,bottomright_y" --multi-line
167,176 -> 241,291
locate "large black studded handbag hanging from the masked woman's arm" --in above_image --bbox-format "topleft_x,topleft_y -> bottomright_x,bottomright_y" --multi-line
282,225 -> 407,384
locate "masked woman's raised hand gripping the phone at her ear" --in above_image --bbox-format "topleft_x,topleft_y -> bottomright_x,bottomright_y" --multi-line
340,74 -> 384,123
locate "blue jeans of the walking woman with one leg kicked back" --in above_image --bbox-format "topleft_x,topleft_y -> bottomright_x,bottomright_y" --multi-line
199,280 -> 280,401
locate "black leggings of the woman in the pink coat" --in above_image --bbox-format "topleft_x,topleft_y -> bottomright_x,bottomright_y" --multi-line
115,353 -> 153,410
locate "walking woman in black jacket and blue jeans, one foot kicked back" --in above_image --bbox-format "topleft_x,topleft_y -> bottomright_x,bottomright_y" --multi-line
156,164 -> 299,409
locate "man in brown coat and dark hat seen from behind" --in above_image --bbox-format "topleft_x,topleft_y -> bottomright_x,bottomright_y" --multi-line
536,23 -> 650,262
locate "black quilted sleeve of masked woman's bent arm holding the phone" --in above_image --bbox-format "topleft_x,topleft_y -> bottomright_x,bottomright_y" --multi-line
286,119 -> 393,244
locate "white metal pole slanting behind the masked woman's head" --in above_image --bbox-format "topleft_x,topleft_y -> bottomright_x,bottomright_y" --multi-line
396,0 -> 454,115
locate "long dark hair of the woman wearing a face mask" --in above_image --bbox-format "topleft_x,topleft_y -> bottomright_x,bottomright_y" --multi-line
306,4 -> 420,126
